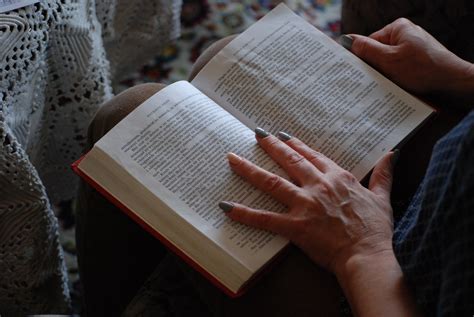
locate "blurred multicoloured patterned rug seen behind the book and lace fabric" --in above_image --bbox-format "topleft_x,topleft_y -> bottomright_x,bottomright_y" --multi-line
61,0 -> 342,312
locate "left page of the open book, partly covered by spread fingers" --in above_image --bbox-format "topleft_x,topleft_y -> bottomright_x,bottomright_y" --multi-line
95,81 -> 287,271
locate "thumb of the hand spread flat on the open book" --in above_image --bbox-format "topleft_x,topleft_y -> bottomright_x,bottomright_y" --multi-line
369,150 -> 400,200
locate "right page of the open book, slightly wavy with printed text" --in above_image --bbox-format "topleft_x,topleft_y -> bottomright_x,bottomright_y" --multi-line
192,4 -> 432,179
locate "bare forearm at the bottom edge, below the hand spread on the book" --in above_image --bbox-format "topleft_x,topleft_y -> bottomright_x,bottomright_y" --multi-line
336,250 -> 419,316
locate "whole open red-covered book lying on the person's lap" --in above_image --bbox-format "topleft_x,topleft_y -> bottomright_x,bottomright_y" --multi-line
73,4 -> 433,295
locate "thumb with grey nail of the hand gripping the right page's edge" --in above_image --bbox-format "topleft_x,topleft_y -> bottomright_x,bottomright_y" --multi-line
350,34 -> 395,69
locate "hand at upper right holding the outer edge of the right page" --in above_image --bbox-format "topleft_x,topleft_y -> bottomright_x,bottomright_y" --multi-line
350,18 -> 474,101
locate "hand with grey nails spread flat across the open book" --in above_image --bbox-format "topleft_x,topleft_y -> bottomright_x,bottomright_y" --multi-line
221,129 -> 394,275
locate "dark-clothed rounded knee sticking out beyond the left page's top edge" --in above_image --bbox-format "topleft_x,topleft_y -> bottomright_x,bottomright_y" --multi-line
88,83 -> 166,146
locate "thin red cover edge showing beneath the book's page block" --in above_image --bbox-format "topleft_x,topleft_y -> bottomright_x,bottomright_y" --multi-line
71,155 -> 288,298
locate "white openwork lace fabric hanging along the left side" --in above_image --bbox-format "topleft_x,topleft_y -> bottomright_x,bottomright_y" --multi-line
0,0 -> 181,314
